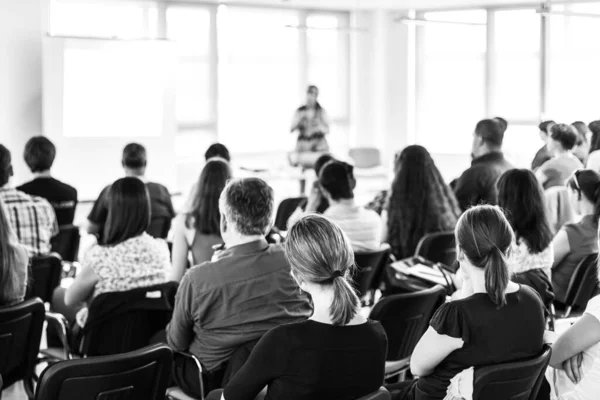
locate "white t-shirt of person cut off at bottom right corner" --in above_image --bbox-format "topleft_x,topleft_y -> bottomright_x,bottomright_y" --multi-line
546,295 -> 600,400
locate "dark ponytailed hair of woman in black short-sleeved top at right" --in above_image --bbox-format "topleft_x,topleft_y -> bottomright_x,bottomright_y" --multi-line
455,206 -> 514,307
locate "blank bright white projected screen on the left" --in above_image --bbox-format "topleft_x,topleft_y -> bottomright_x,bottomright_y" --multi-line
62,42 -> 168,137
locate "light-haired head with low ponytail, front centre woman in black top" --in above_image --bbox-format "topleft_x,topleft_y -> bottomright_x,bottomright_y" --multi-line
285,214 -> 359,326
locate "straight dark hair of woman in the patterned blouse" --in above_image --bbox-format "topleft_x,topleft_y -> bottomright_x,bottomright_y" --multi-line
102,177 -> 150,246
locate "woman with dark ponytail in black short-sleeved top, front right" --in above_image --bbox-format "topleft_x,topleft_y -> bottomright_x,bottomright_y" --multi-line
389,206 -> 545,400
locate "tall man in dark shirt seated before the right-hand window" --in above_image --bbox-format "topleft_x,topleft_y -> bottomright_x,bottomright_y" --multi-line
454,119 -> 512,211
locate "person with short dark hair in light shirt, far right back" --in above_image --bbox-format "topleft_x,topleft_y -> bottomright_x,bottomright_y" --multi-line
535,124 -> 583,189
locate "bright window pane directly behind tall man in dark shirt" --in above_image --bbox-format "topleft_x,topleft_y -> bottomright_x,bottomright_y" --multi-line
416,10 -> 486,154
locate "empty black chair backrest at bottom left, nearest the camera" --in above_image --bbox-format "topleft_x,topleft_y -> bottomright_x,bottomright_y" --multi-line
35,344 -> 173,400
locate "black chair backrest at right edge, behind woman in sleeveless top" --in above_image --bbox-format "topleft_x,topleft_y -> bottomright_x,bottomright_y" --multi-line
565,253 -> 598,309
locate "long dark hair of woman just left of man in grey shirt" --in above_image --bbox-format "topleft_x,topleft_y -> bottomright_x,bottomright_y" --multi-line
186,158 -> 231,235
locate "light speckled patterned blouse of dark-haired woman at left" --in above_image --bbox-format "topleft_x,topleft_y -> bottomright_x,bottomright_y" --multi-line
82,233 -> 171,297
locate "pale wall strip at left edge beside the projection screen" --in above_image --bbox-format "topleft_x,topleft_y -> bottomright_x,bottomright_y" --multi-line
0,0 -> 45,182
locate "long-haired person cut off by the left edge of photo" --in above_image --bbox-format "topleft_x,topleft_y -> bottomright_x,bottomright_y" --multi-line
0,199 -> 29,306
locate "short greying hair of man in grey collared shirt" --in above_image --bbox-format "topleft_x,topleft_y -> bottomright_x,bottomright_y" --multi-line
219,178 -> 274,236
